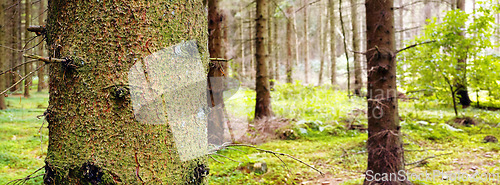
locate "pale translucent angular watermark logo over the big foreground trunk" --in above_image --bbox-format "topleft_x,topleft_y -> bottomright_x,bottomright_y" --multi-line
128,41 -> 239,161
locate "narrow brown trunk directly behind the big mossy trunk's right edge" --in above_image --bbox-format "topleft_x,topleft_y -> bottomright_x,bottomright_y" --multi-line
207,0 -> 227,145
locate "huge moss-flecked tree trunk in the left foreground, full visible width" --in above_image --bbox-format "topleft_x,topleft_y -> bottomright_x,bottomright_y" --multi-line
44,0 -> 208,184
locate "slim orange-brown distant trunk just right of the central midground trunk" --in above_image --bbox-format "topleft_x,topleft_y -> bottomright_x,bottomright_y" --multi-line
286,6 -> 295,83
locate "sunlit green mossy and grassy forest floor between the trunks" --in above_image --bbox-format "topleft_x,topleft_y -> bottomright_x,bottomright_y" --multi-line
0,84 -> 500,184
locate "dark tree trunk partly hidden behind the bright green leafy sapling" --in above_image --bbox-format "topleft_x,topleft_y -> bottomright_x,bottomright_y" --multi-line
455,0 -> 472,108
